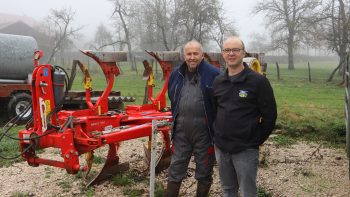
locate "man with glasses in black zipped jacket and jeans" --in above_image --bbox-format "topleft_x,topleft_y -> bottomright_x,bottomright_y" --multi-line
213,37 -> 277,197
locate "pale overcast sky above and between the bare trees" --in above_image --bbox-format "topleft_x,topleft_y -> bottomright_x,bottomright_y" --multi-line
0,0 -> 265,46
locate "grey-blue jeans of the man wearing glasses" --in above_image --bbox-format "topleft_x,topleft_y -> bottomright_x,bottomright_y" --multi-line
215,146 -> 259,197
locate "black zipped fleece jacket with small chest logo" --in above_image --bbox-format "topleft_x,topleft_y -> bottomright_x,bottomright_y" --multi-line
213,65 -> 277,153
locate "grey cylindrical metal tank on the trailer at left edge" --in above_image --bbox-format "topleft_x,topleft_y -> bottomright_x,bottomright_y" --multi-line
0,34 -> 38,80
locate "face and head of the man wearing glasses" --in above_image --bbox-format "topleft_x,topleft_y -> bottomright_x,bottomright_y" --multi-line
222,39 -> 245,68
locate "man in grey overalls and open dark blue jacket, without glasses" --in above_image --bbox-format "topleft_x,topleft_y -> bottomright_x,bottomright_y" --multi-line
166,41 -> 220,197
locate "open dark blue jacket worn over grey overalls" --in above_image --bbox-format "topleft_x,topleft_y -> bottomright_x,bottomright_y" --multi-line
168,60 -> 220,140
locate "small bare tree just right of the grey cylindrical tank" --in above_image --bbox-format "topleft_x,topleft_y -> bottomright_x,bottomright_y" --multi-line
45,8 -> 82,63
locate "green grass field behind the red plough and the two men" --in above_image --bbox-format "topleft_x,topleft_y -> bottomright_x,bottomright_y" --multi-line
0,58 -> 346,166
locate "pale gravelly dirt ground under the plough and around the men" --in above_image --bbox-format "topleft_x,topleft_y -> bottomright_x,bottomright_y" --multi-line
0,139 -> 350,197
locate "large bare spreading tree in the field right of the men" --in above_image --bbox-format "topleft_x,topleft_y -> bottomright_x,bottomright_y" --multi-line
255,0 -> 320,70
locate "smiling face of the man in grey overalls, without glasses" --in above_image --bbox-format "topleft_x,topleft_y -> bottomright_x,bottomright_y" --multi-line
184,44 -> 204,72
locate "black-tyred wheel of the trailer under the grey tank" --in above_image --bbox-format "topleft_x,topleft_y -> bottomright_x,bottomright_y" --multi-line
7,93 -> 33,123
